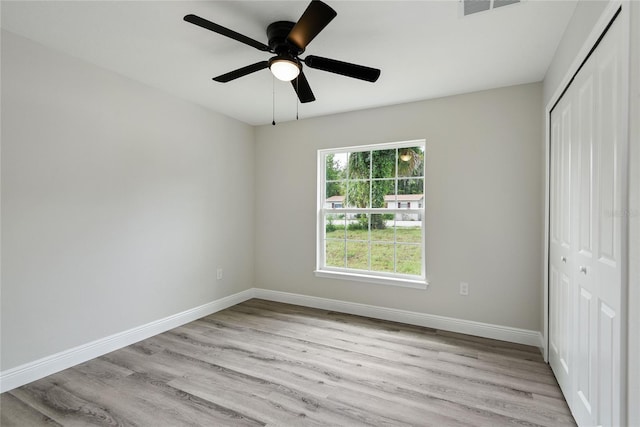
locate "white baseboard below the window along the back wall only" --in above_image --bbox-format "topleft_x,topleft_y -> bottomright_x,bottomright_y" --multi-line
254,288 -> 543,349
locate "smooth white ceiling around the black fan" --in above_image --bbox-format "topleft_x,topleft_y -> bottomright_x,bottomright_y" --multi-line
1,0 -> 577,125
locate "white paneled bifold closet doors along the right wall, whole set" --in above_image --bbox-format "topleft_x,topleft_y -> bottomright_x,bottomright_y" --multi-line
549,11 -> 626,426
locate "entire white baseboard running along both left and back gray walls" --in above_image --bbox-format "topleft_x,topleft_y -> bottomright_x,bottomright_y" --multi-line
0,288 -> 543,393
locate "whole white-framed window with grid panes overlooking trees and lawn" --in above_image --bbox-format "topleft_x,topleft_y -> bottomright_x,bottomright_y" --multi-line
316,140 -> 426,288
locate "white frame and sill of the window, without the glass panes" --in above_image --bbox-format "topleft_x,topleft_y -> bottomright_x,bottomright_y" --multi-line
315,139 -> 429,289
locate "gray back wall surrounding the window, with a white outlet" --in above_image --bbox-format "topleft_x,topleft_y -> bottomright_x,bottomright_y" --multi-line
255,83 -> 544,331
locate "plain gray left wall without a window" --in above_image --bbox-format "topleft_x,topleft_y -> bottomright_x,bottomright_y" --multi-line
1,32 -> 254,370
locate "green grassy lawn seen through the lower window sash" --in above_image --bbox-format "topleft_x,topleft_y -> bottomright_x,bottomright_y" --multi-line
325,227 -> 422,275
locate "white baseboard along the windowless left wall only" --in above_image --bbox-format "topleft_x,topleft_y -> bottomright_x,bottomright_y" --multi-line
0,289 -> 253,393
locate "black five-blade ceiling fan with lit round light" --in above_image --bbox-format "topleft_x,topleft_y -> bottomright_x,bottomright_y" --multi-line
184,0 -> 380,103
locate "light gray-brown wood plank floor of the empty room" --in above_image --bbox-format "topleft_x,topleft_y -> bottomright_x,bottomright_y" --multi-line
0,299 -> 575,427
